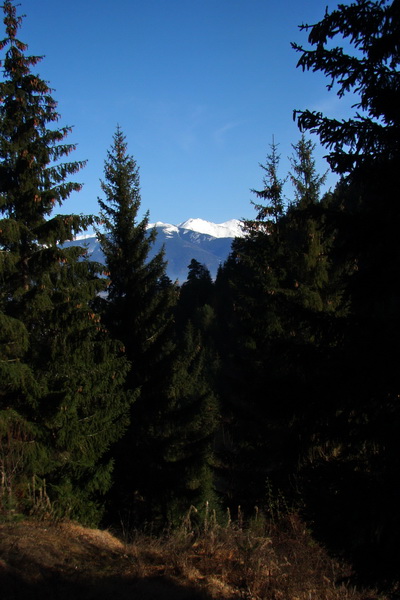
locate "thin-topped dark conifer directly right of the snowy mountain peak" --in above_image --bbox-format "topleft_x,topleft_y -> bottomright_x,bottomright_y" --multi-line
216,142 -> 290,511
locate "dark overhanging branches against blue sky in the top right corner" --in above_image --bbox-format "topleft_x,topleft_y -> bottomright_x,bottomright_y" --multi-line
292,0 -> 400,175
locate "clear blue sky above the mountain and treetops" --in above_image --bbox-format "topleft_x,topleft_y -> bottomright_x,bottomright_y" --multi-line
14,0 -> 352,224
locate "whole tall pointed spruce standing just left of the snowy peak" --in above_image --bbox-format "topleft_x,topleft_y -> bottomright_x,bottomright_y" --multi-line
98,127 -> 182,525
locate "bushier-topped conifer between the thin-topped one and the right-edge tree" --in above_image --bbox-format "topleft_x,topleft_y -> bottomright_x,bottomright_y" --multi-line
272,135 -> 345,477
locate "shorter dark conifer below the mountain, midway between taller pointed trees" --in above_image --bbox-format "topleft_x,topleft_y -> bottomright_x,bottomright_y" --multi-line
167,259 -> 220,518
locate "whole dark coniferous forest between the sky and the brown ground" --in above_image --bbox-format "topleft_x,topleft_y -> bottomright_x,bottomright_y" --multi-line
0,0 -> 400,582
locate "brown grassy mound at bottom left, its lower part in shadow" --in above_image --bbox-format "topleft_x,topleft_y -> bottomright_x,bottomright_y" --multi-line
0,522 -> 238,600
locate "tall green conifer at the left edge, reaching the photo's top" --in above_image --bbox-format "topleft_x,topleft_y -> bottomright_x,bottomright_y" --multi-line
0,0 -> 130,522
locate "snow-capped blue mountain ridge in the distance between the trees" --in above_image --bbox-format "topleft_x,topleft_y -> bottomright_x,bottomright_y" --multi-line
66,219 -> 244,283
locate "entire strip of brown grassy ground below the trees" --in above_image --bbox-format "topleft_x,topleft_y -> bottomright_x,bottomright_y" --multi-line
0,515 -> 385,600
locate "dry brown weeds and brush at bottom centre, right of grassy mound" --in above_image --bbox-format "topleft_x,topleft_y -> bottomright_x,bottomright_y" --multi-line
125,507 -> 385,600
